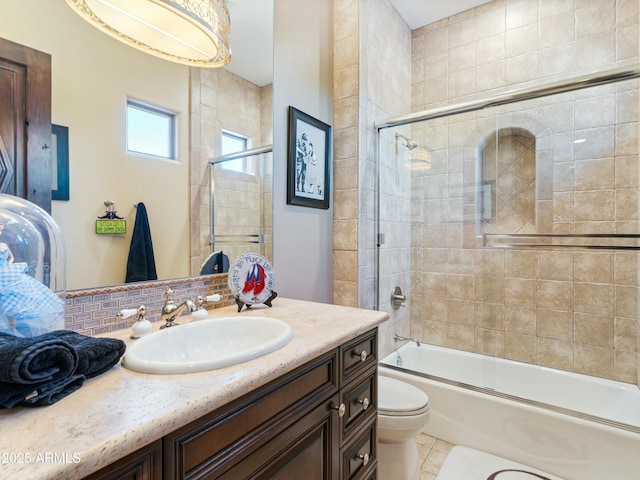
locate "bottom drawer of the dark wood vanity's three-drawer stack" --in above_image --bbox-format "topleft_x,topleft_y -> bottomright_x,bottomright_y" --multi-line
342,417 -> 378,480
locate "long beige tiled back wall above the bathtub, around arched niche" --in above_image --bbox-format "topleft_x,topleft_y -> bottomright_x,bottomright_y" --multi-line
411,0 -> 638,383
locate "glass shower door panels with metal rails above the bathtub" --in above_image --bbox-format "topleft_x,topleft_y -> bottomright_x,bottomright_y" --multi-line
375,66 -> 640,388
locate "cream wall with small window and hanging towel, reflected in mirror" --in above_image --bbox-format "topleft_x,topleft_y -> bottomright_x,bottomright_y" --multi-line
0,0 -> 189,289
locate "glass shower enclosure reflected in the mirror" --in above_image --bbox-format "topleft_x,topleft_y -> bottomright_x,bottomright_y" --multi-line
202,145 -> 273,274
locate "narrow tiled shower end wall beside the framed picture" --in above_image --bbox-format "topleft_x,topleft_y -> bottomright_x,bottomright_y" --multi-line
333,0 -> 411,354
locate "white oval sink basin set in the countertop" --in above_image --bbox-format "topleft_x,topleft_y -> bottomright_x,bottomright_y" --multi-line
122,316 -> 293,374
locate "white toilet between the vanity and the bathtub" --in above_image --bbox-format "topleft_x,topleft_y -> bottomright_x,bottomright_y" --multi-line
378,373 -> 429,480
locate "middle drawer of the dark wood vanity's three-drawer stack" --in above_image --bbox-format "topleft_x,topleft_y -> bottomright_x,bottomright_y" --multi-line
340,366 -> 378,442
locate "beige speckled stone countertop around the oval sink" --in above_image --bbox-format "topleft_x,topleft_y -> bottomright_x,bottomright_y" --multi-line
0,298 -> 387,480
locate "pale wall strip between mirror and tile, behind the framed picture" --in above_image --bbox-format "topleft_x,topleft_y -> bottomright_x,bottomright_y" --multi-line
273,0 -> 333,303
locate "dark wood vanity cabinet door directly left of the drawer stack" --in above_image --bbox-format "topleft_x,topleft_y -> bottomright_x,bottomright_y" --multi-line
217,395 -> 340,480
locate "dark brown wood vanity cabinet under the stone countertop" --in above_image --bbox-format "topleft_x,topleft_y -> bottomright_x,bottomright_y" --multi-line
83,330 -> 378,480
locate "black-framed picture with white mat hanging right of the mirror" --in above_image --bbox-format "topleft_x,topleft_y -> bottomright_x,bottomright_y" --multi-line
287,106 -> 331,209
